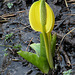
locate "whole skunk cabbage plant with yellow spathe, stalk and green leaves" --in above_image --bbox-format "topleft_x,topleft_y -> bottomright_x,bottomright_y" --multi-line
18,0 -> 56,74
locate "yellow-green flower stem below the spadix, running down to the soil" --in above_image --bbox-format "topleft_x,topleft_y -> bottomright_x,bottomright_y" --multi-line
42,25 -> 54,69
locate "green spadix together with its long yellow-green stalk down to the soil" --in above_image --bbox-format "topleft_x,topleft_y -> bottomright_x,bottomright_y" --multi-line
40,0 -> 54,69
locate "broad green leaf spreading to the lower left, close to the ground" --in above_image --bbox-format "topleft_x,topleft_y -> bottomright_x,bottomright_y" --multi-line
17,50 -> 49,74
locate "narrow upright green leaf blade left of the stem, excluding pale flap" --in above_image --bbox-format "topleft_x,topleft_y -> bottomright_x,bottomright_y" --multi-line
40,33 -> 46,58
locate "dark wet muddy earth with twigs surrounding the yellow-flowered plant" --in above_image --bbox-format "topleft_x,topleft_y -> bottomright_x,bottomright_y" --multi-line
0,0 -> 75,75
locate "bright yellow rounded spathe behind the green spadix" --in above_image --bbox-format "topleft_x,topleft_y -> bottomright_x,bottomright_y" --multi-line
29,1 -> 55,33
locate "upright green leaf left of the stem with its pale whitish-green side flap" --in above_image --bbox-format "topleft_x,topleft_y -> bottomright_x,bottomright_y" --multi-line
30,33 -> 46,58
